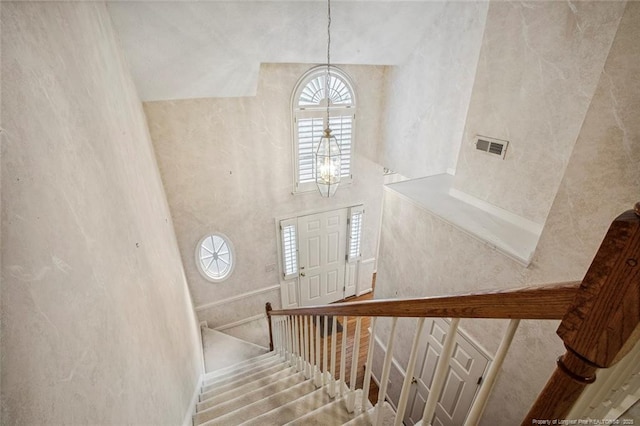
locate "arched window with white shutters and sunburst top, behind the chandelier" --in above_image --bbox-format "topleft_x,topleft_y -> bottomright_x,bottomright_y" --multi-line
292,66 -> 356,192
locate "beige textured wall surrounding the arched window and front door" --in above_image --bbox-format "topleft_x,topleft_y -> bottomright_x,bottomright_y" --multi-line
144,64 -> 385,345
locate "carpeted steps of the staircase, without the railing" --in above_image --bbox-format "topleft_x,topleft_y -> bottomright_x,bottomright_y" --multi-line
193,352 -> 394,426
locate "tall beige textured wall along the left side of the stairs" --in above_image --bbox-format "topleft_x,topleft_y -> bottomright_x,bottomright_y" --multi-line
0,2 -> 202,425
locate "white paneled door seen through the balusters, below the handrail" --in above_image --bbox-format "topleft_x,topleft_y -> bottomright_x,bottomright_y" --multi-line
405,318 -> 489,426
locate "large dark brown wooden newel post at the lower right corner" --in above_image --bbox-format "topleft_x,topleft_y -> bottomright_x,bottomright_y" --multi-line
522,203 -> 640,426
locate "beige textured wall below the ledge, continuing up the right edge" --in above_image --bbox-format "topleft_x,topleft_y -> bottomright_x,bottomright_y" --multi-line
376,2 -> 640,425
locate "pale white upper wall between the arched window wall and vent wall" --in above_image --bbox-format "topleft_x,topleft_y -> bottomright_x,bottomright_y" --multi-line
383,2 -> 489,178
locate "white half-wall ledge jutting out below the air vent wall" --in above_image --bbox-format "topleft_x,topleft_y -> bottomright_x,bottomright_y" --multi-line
385,174 -> 543,267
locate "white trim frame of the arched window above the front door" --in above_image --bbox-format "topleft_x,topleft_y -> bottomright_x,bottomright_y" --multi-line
291,65 -> 357,195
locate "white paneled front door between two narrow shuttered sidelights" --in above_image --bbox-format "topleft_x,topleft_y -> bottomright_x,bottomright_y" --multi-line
298,209 -> 348,306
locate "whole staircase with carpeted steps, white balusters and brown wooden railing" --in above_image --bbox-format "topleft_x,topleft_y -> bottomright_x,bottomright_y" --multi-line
193,203 -> 640,426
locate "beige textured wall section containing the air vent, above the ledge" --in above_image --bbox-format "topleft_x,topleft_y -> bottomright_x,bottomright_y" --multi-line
454,1 -> 624,224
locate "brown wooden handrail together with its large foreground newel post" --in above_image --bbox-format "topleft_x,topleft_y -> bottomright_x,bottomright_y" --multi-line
267,203 -> 640,426
